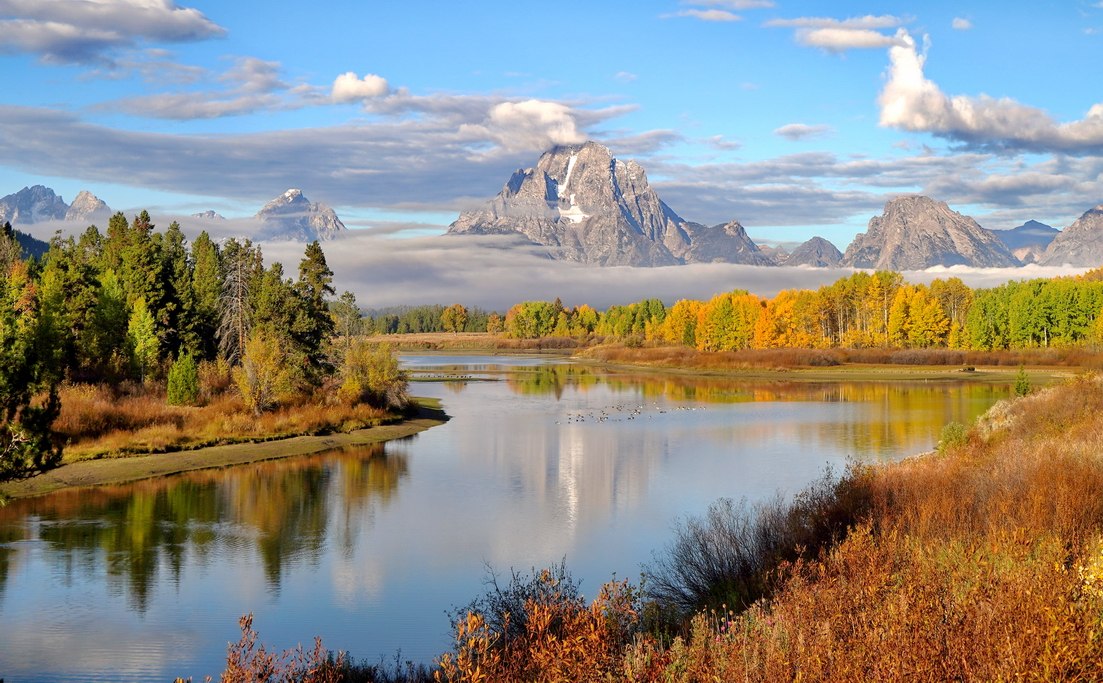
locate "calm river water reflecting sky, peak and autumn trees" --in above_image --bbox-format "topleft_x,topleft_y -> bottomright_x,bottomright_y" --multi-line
0,355 -> 1009,683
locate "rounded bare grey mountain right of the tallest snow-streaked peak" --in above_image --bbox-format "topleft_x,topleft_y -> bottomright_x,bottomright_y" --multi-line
843,195 -> 1021,270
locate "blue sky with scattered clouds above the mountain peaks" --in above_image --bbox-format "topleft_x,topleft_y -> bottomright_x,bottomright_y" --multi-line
0,0 -> 1103,248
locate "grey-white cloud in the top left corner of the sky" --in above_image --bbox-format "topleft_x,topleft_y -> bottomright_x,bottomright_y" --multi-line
0,0 -> 226,64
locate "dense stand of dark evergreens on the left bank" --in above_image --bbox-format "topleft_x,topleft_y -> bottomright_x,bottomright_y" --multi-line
0,211 -> 405,477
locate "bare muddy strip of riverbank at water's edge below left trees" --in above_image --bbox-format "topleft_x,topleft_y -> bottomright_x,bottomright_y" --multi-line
0,398 -> 448,499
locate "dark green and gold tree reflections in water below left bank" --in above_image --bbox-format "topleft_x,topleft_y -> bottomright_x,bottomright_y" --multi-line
0,445 -> 408,612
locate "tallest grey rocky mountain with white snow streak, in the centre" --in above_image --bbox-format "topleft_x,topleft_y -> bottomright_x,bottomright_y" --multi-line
448,142 -> 772,266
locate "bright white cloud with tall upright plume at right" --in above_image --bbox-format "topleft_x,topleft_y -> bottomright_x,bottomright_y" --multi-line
878,30 -> 1103,153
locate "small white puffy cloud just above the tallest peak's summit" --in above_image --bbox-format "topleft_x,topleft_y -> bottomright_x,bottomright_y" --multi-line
460,99 -> 586,150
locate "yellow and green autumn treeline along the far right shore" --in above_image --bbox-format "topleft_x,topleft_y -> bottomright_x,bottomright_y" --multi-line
502,271 -> 1103,351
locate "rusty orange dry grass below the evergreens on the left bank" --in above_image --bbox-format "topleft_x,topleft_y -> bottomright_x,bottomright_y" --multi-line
54,384 -> 394,462
